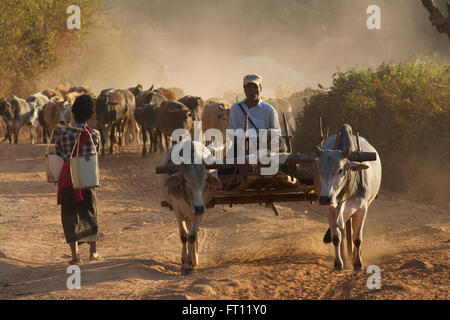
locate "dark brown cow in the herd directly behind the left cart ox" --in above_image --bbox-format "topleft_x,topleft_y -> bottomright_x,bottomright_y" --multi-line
156,100 -> 193,149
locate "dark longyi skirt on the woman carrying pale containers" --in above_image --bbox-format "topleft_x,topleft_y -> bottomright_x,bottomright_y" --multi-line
61,187 -> 98,244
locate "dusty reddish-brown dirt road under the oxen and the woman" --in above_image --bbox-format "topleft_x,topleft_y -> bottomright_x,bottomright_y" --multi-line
0,141 -> 450,299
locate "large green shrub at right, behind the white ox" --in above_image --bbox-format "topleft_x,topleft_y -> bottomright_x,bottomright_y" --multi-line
295,57 -> 450,205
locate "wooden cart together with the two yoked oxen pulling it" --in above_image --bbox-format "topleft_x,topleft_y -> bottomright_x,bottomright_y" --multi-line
156,114 -> 381,274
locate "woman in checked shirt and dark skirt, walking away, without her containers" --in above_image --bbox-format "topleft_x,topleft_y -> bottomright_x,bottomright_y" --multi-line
55,95 -> 100,264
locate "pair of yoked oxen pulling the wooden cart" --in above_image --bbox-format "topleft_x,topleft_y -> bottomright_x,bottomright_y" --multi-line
160,125 -> 381,274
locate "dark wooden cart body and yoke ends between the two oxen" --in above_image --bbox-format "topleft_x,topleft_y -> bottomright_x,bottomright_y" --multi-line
156,114 -> 376,215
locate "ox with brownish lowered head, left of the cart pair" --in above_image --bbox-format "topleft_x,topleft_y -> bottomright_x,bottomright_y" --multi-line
160,140 -> 222,274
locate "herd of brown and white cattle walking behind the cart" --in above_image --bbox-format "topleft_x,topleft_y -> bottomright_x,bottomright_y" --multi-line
0,84 -> 293,156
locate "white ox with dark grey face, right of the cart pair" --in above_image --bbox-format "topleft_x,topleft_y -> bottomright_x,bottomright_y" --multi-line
317,125 -> 381,270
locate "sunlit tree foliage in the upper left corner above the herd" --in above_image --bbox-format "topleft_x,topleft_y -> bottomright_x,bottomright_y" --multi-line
0,0 -> 101,95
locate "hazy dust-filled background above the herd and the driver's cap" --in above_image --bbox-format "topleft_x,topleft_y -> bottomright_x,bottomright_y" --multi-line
43,0 -> 450,98
